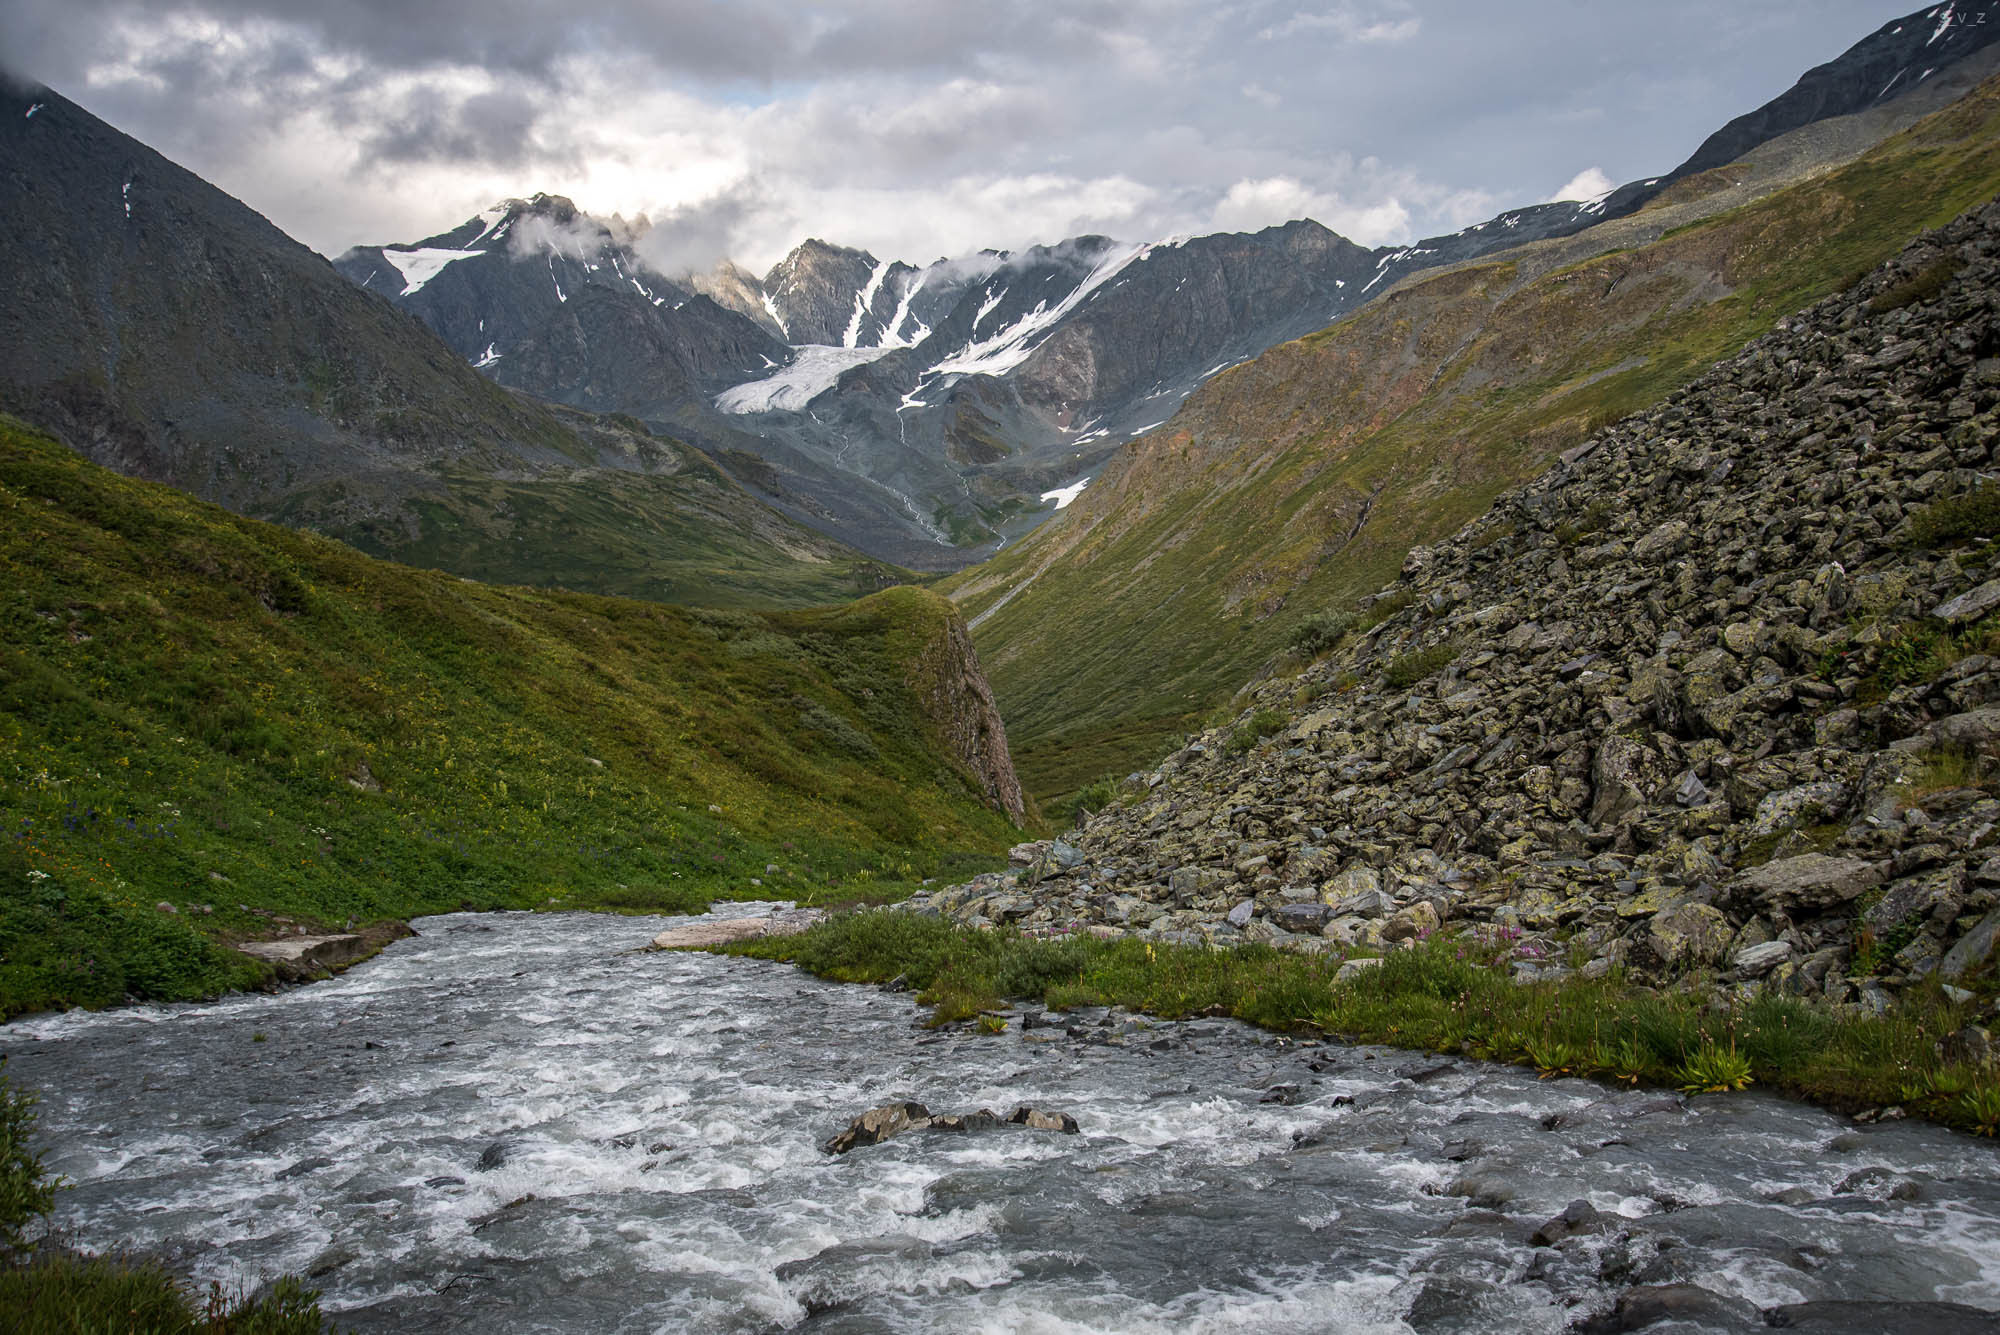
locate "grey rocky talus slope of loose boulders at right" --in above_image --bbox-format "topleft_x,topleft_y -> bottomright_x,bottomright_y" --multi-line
928,204 -> 2000,1007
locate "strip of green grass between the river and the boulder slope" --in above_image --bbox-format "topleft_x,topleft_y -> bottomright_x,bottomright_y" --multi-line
724,911 -> 2000,1133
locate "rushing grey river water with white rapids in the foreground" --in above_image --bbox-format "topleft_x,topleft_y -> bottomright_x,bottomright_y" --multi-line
11,915 -> 2000,1335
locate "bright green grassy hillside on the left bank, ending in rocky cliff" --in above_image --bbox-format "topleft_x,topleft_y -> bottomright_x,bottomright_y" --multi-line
0,418 -> 1012,1015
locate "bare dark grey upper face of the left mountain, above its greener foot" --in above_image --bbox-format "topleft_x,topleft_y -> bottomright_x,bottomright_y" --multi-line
0,88 -> 580,508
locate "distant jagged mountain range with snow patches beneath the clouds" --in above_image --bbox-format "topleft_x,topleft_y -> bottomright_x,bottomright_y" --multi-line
336,0 -> 2000,570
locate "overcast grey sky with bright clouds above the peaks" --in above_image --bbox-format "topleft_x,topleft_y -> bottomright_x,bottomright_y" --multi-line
0,0 -> 1916,272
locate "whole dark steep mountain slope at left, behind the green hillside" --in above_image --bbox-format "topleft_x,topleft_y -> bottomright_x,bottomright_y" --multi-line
0,78 -> 896,602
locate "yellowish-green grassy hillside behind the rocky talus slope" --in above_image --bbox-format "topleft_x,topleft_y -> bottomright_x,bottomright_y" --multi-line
942,72 -> 2000,803
